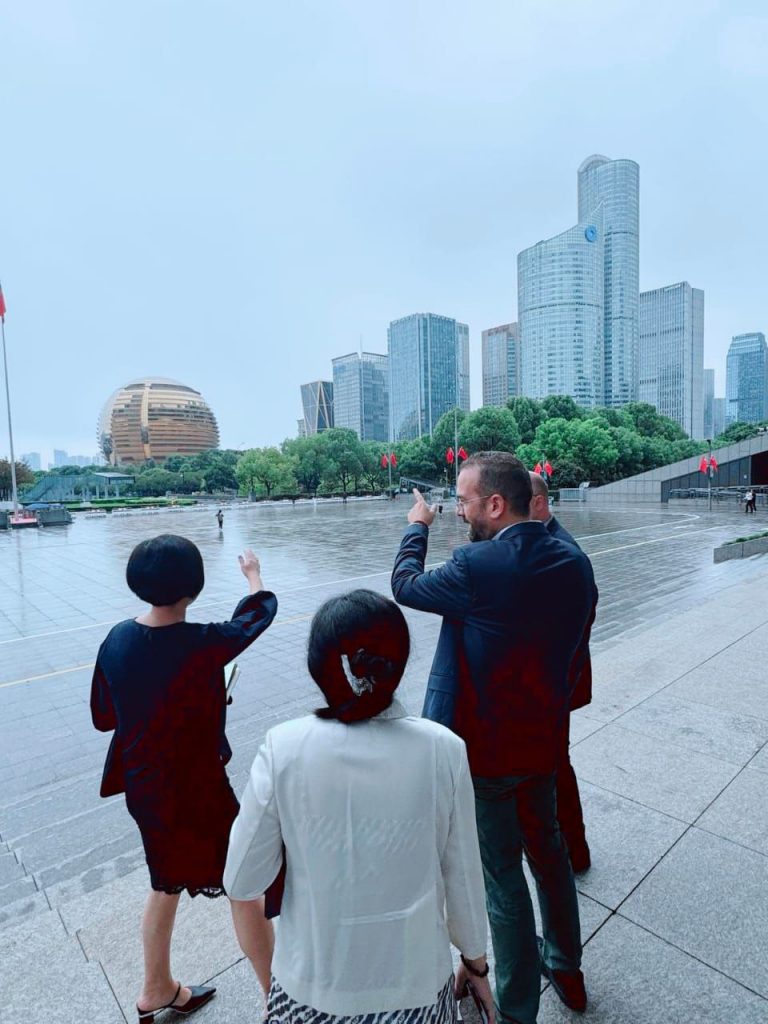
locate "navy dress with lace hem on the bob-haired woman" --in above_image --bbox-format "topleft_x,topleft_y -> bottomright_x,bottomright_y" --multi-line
91,591 -> 278,896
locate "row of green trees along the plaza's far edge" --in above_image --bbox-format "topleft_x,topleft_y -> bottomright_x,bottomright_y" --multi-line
16,395 -> 764,498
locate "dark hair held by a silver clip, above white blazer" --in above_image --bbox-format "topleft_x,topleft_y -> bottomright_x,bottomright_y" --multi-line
307,590 -> 411,725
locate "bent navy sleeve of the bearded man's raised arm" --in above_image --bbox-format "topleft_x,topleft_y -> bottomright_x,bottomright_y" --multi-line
392,523 -> 474,618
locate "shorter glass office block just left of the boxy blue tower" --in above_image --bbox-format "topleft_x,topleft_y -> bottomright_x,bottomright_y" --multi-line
333,352 -> 389,441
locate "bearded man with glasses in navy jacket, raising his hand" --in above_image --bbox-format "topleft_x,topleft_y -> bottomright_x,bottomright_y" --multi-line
392,452 -> 594,1024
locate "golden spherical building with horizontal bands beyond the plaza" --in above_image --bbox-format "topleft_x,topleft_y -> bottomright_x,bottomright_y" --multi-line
97,377 -> 219,466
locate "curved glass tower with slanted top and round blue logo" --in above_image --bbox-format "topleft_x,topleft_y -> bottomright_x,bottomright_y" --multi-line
517,222 -> 604,408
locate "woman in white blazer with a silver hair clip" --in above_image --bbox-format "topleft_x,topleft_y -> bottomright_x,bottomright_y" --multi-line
224,590 -> 495,1024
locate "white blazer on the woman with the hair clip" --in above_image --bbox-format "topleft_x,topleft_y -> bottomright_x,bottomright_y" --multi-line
224,700 -> 487,1016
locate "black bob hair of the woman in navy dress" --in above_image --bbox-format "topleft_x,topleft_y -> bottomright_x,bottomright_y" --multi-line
125,534 -> 205,607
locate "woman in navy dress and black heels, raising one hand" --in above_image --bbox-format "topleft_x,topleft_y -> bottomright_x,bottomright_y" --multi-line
91,534 -> 278,1024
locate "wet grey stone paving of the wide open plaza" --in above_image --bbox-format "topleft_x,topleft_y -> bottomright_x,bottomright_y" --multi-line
0,499 -> 768,1024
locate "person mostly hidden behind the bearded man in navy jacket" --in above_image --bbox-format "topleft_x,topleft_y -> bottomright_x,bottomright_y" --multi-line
530,472 -> 598,874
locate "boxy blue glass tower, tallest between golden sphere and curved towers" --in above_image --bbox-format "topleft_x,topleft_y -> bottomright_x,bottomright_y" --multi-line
387,313 -> 469,440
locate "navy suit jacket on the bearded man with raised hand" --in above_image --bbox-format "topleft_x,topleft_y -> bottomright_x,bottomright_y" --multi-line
392,521 -> 594,776
